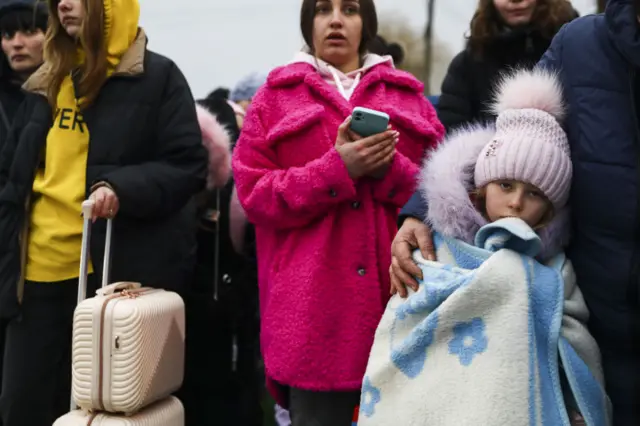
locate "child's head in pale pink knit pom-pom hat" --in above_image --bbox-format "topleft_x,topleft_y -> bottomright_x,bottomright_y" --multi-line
473,74 -> 572,236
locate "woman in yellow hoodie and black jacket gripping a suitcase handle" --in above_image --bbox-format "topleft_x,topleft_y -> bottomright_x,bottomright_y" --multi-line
0,0 -> 207,426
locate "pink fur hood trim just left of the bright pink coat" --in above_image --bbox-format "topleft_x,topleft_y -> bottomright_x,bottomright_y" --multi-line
196,104 -> 231,189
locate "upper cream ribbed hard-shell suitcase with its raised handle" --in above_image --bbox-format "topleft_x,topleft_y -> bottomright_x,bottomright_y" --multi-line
72,201 -> 185,414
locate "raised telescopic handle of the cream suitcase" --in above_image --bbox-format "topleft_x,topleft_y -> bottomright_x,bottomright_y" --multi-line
78,200 -> 113,303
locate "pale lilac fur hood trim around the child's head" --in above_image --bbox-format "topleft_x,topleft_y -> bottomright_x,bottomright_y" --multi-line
419,125 -> 570,260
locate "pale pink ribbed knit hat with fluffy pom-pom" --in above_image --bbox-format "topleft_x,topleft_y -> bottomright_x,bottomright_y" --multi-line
475,70 -> 573,210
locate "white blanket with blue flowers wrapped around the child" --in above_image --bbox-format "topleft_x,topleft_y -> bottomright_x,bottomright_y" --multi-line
358,218 -> 611,426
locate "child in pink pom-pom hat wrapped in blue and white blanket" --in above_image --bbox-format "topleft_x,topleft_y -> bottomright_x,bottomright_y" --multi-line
359,70 -> 610,426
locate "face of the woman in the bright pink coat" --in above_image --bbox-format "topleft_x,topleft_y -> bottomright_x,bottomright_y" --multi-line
313,0 -> 362,68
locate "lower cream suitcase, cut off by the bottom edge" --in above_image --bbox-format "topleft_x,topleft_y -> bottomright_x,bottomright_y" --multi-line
53,396 -> 184,426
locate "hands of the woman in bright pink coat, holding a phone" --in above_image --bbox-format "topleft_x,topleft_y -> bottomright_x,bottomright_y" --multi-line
335,116 -> 398,179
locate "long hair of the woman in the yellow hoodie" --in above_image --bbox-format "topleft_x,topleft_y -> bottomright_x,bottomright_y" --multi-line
44,0 -> 108,111
